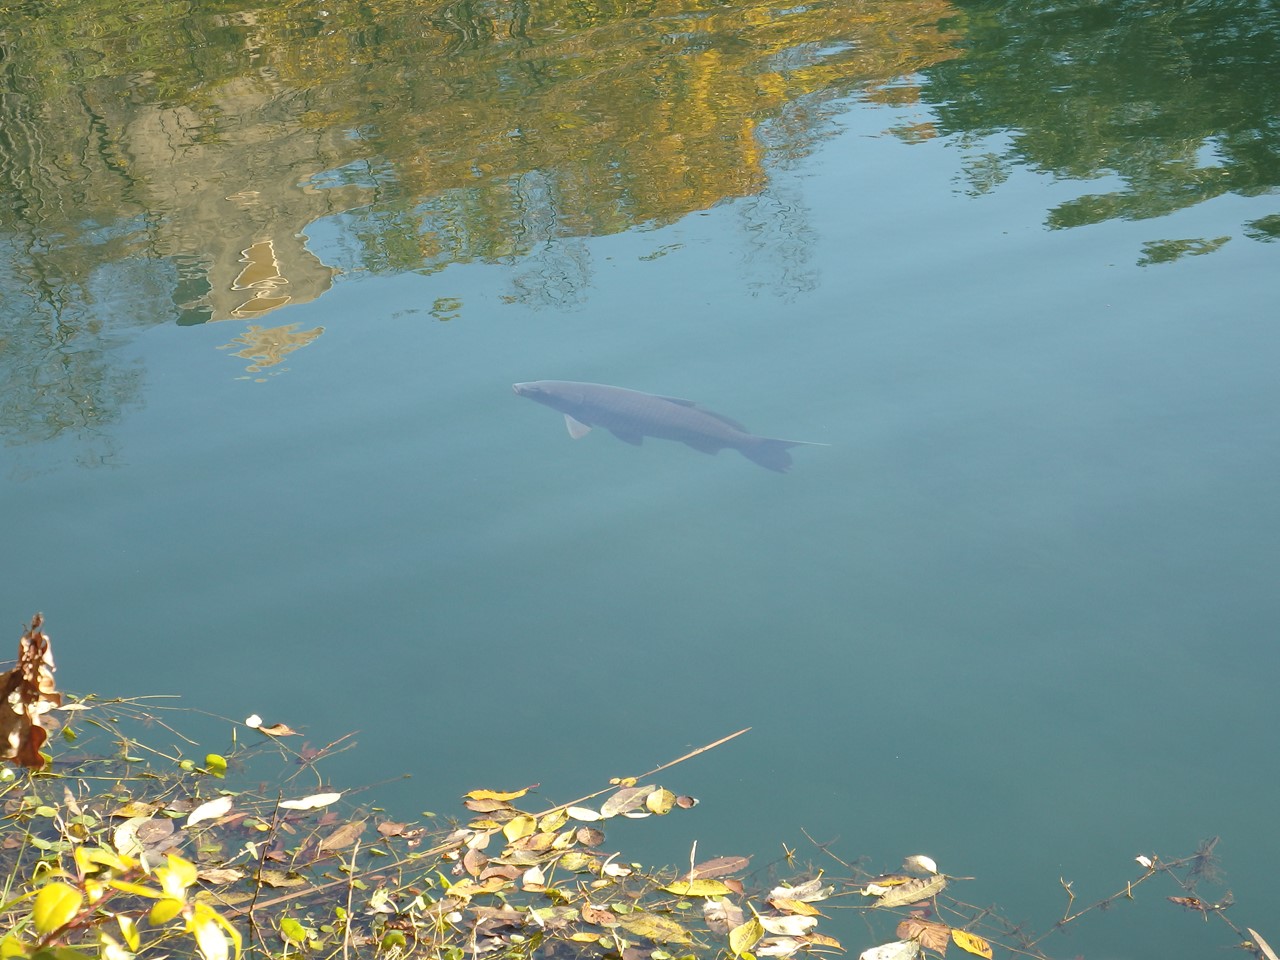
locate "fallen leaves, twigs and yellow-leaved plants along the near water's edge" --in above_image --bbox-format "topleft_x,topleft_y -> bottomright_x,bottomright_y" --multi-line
0,616 -> 1277,960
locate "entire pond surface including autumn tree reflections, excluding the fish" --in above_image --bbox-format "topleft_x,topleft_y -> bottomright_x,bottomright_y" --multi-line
0,1 -> 1280,957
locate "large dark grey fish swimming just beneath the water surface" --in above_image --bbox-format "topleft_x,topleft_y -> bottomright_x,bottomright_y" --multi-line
512,380 -> 824,474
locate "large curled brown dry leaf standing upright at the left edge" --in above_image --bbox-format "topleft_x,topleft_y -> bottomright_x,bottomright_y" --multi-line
0,613 -> 63,769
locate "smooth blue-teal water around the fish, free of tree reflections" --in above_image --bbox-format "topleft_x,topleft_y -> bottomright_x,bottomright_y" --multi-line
0,3 -> 1280,957
